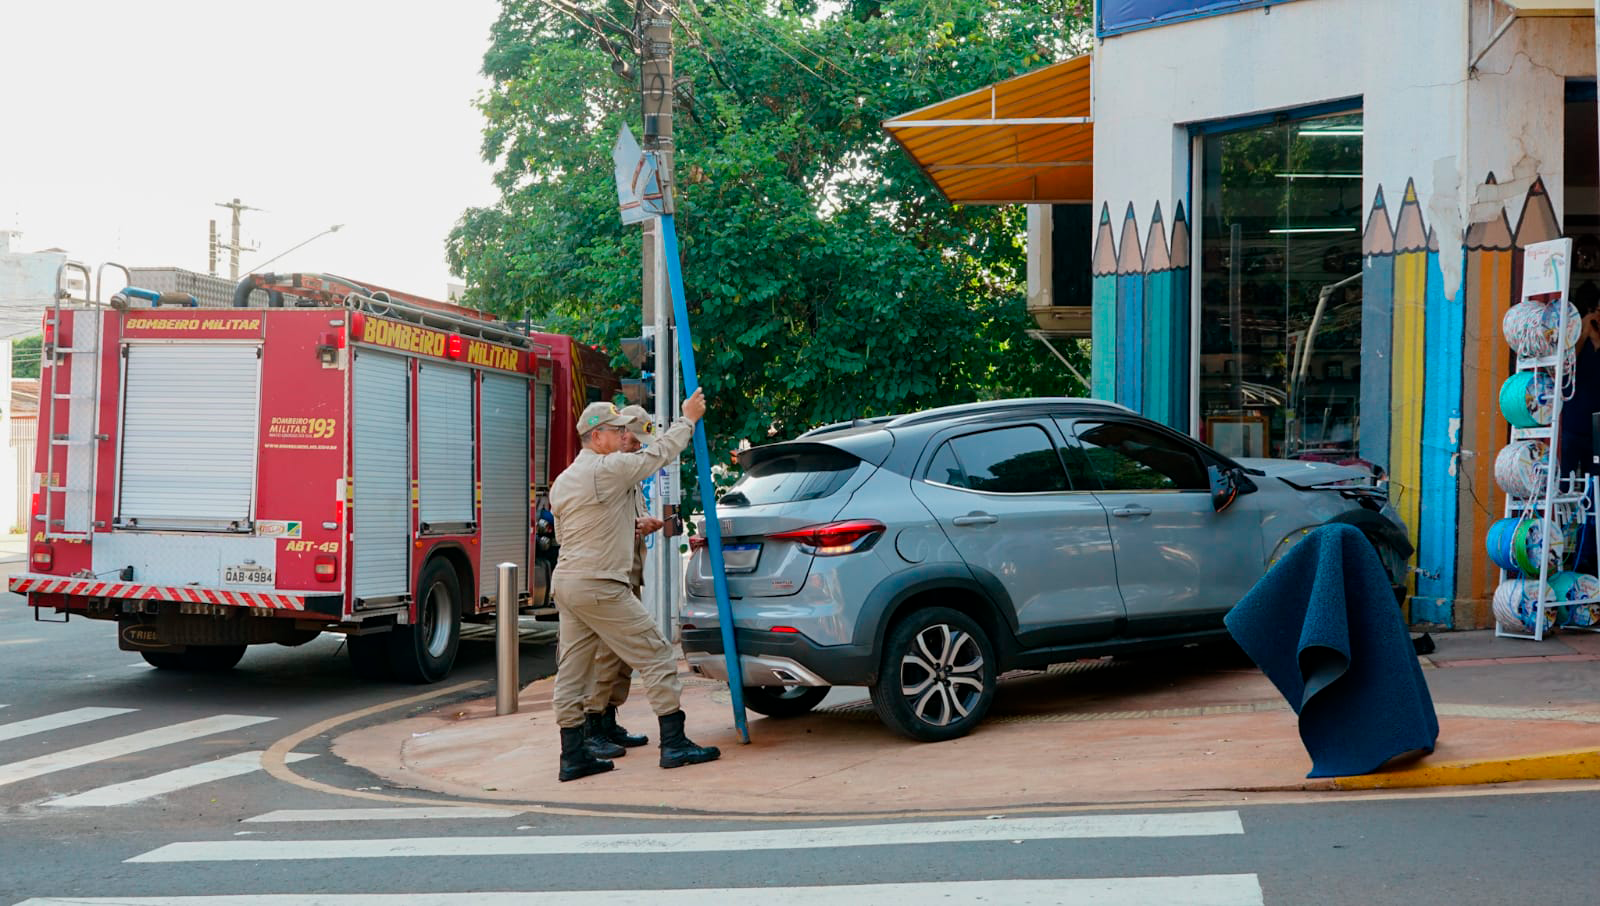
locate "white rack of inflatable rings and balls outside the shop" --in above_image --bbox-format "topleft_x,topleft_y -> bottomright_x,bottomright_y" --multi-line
1485,239 -> 1600,640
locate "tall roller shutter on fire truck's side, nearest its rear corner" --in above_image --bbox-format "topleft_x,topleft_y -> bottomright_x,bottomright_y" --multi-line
350,349 -> 411,597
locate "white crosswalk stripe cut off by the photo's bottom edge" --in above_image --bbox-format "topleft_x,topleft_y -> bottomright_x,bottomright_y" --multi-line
18,874 -> 1262,906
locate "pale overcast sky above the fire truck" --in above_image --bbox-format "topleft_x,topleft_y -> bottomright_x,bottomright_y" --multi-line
0,0 -> 499,298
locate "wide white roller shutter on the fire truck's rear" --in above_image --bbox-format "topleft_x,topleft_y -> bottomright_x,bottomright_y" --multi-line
117,343 -> 261,531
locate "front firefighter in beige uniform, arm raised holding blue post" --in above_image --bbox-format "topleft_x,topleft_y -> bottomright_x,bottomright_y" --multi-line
550,391 -> 722,781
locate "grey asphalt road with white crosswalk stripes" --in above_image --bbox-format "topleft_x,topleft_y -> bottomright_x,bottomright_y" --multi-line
0,569 -> 1600,906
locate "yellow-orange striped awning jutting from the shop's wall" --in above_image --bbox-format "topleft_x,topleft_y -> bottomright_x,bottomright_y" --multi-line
883,54 -> 1094,205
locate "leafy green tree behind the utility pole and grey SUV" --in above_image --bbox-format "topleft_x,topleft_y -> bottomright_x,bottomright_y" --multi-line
448,0 -> 1088,458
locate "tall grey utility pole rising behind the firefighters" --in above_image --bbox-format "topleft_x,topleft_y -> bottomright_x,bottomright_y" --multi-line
634,0 -> 682,640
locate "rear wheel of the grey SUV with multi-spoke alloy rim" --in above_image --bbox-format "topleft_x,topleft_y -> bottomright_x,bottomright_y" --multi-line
870,607 -> 995,743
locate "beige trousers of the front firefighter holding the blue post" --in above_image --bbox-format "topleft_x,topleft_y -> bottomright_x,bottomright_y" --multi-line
550,570 -> 683,727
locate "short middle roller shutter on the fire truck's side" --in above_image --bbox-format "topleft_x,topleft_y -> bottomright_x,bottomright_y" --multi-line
416,362 -> 474,525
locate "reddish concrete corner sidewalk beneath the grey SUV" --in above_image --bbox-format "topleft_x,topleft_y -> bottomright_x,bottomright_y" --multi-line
334,632 -> 1600,816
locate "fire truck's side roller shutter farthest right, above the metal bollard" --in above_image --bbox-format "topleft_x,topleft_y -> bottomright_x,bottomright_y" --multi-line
478,375 -> 530,597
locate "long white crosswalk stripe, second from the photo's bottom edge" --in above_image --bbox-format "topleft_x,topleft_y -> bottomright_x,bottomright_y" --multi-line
128,812 -> 1245,863
